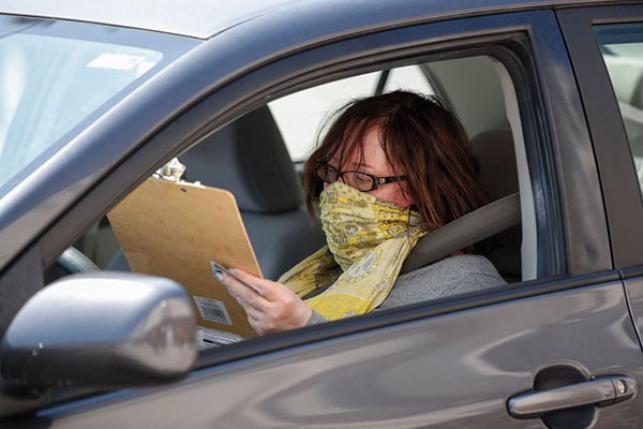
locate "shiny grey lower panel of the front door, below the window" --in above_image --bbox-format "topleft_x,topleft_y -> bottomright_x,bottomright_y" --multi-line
36,280 -> 643,428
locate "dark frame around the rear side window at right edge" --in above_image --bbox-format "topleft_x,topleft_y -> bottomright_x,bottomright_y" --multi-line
556,5 -> 643,268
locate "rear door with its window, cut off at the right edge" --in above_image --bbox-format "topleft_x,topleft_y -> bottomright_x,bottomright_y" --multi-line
559,0 -> 643,378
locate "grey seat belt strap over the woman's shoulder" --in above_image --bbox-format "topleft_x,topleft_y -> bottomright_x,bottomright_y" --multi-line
400,192 -> 520,275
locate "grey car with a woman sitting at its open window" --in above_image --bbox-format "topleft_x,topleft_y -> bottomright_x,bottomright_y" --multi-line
0,0 -> 643,428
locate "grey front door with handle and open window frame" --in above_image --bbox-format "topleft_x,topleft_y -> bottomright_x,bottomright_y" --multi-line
5,2 -> 643,428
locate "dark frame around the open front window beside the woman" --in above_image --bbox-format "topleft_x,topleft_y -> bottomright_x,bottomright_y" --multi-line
5,11 -> 617,412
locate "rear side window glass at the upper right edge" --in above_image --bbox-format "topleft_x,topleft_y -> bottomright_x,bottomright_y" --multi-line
594,24 -> 643,193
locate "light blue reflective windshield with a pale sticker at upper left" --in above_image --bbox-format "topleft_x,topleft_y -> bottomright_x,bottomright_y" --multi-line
0,16 -> 198,197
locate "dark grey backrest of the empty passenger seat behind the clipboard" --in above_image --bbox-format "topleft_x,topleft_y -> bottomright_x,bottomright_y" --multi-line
179,106 -> 302,213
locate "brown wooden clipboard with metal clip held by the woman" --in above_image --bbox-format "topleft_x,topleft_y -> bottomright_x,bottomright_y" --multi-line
107,178 -> 262,337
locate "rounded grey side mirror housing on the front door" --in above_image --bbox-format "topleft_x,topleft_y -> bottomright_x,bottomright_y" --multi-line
0,272 -> 197,388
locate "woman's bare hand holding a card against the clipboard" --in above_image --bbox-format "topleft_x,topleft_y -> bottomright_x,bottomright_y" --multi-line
219,269 -> 312,335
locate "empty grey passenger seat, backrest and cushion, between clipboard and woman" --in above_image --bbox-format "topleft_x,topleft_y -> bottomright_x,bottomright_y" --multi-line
179,106 -> 325,279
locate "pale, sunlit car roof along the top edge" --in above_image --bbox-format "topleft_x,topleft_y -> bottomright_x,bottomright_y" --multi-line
0,0 -> 628,39
